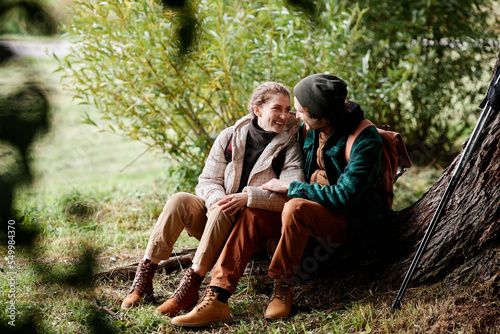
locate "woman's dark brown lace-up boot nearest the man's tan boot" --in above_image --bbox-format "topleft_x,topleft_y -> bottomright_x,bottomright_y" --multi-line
156,268 -> 203,317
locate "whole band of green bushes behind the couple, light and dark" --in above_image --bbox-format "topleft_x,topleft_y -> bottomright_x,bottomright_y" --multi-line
61,0 -> 498,180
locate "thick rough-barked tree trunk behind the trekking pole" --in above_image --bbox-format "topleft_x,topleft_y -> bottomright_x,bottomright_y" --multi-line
386,108 -> 500,285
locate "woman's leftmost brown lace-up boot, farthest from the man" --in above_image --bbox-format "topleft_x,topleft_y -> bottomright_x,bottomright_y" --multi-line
121,260 -> 158,310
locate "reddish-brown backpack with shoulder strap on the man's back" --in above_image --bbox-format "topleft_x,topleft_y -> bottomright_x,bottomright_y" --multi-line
345,119 -> 412,208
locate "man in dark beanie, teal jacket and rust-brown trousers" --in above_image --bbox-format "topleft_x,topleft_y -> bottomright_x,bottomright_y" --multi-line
172,74 -> 387,327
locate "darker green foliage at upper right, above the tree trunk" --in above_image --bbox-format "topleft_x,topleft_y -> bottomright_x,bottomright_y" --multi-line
355,0 -> 500,163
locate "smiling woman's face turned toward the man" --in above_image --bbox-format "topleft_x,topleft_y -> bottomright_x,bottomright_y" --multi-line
253,94 -> 290,133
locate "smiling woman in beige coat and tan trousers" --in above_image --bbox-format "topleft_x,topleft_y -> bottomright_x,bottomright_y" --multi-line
121,82 -> 303,316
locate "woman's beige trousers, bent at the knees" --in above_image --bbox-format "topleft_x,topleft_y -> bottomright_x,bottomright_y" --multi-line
144,192 -> 233,275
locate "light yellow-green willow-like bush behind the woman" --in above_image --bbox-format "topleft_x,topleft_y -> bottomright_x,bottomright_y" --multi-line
61,0 -> 364,181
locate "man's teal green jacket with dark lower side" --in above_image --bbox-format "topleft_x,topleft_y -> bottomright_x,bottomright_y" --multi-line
288,113 -> 389,235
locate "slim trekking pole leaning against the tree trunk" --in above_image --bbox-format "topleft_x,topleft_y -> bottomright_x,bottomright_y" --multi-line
392,69 -> 500,309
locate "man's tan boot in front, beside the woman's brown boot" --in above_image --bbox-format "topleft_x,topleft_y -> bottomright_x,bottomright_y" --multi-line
170,288 -> 231,327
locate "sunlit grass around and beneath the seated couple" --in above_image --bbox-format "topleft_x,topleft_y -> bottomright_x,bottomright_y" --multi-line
0,54 -> 499,333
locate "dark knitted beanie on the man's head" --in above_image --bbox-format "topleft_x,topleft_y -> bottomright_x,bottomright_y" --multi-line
293,73 -> 347,119
